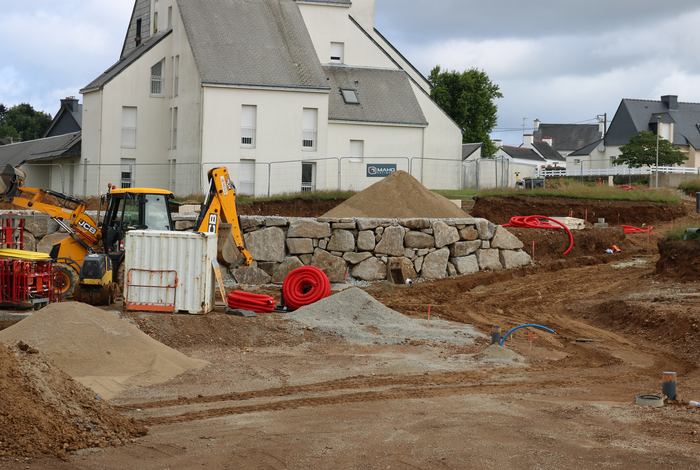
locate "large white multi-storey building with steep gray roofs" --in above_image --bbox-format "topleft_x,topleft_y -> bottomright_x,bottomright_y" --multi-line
75,0 -> 462,195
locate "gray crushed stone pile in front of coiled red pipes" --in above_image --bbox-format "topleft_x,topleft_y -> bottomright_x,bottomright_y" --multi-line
285,287 -> 486,345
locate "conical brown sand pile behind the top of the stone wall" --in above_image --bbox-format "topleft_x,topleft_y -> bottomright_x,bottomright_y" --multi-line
323,170 -> 467,219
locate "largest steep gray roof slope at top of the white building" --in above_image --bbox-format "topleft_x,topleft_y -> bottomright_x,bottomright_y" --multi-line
177,0 -> 327,88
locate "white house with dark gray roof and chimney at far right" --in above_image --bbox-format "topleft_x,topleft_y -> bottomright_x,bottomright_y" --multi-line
567,95 -> 700,169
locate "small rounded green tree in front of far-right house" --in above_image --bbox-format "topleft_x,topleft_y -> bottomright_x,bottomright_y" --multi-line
614,131 -> 688,168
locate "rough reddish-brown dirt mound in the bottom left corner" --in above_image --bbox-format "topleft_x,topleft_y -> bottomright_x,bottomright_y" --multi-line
0,342 -> 147,459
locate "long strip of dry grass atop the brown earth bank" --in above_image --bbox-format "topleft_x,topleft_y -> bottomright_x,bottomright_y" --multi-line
479,181 -> 681,203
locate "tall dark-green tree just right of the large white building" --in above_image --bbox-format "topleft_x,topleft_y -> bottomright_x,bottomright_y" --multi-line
428,65 -> 503,157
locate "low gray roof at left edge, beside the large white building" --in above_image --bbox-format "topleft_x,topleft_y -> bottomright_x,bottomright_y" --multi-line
0,132 -> 81,167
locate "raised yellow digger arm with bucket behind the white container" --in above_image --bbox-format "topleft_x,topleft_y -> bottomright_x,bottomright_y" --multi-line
195,167 -> 253,268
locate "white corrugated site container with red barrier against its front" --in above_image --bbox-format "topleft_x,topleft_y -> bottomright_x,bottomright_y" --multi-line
124,230 -> 218,314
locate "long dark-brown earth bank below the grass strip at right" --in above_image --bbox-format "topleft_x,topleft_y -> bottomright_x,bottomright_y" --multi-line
471,196 -> 688,226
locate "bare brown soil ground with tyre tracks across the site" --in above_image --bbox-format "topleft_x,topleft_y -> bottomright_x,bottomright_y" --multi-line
0,194 -> 700,469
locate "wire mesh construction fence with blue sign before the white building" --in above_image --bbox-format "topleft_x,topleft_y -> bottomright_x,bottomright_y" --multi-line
16,157 -> 584,199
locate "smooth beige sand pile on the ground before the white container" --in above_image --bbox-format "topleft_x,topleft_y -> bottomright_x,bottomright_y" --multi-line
0,302 -> 208,399
